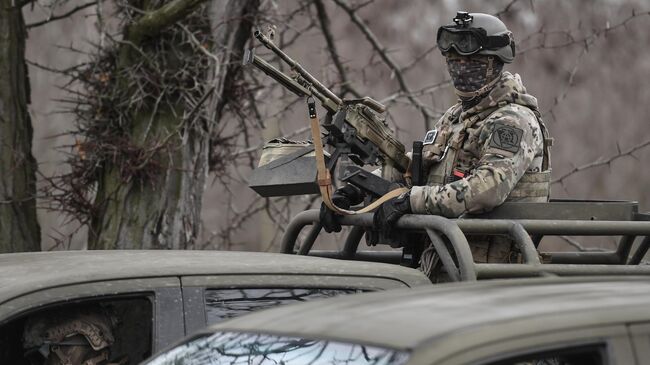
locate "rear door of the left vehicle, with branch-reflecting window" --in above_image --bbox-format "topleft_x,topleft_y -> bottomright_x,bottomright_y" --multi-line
181,274 -> 408,334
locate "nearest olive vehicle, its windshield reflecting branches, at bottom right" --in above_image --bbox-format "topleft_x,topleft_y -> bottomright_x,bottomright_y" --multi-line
146,277 -> 650,365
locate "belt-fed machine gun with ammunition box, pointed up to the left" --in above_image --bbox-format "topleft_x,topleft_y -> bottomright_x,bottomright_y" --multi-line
243,30 -> 410,198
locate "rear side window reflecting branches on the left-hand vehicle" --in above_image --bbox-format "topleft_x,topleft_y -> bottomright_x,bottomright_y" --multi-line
205,288 -> 362,324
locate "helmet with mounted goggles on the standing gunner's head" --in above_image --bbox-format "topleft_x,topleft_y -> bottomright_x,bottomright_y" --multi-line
436,11 -> 515,63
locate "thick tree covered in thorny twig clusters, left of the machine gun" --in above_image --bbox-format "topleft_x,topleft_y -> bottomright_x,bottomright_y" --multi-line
41,0 -> 258,249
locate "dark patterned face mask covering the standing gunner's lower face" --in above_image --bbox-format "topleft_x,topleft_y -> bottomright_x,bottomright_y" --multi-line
447,56 -> 503,92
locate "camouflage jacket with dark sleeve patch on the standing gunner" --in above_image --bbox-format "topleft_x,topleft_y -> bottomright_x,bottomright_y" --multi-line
410,72 -> 550,217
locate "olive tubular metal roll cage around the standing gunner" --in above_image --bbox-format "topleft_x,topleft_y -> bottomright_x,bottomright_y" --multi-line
282,201 -> 650,281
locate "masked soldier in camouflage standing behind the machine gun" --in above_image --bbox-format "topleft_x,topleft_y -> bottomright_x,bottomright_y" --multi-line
321,12 -> 550,278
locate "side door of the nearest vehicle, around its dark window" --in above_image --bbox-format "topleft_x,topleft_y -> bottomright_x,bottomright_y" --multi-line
420,324 -> 637,365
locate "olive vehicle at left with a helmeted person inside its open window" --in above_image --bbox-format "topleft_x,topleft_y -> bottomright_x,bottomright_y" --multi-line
0,250 -> 430,365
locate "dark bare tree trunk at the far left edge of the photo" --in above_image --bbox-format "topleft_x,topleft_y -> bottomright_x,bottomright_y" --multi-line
0,0 -> 41,253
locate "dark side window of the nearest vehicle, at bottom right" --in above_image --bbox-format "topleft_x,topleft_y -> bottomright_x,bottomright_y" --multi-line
489,345 -> 607,365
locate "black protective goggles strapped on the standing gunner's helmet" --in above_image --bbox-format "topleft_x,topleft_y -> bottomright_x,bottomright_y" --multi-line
436,25 -> 511,56
